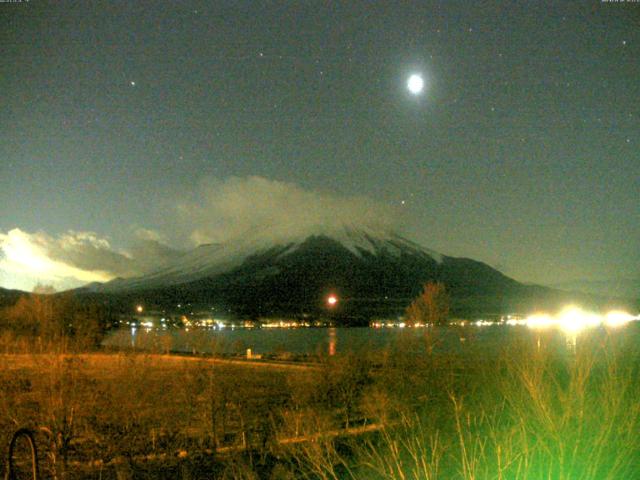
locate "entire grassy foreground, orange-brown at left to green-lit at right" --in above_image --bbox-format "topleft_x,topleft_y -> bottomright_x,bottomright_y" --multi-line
0,330 -> 640,479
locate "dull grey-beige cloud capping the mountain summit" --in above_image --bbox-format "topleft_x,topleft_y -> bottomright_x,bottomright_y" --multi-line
179,176 -> 397,244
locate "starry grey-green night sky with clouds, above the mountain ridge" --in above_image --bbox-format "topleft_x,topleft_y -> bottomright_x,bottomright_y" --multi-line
0,0 -> 640,289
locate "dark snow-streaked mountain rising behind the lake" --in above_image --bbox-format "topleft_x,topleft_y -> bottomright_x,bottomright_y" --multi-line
81,226 -> 604,324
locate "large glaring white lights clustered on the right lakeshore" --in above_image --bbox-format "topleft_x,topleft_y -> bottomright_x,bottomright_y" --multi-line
507,306 -> 640,333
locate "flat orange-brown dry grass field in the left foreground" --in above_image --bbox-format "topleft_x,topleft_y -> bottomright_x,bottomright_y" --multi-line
0,353 -> 318,475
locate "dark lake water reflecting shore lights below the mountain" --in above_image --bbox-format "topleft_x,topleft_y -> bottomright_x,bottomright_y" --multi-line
103,322 -> 640,355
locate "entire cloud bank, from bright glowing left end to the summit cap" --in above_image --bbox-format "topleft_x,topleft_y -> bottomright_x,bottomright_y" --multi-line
0,176 -> 397,290
